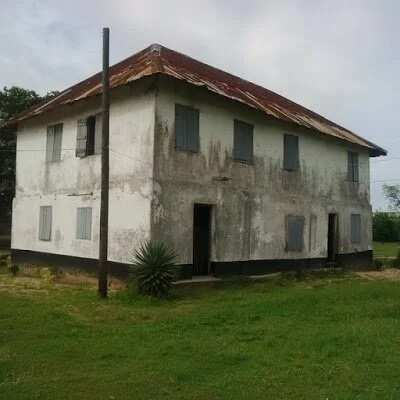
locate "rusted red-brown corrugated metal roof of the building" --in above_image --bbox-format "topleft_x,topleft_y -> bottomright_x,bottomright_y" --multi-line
10,44 -> 386,156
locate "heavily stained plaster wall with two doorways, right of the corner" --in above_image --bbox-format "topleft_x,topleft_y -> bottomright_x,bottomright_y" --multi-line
152,77 -> 372,264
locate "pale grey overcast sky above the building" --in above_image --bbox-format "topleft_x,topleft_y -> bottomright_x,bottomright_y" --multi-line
0,0 -> 400,209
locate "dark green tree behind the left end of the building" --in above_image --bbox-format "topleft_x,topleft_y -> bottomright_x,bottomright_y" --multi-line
0,86 -> 58,227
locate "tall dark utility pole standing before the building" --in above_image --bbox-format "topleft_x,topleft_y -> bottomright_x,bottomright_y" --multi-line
98,28 -> 110,298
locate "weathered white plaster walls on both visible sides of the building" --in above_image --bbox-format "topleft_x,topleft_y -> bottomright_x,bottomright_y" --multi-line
12,74 -> 371,264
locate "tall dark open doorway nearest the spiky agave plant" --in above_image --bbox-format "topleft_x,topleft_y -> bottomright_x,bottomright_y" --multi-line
193,204 -> 212,275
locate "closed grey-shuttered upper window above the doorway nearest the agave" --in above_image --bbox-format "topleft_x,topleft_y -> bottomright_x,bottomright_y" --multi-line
175,104 -> 200,153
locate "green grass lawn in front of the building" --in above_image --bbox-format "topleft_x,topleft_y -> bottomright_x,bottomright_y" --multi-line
0,275 -> 400,400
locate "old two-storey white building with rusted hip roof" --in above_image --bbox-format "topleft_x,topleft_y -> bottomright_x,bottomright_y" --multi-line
8,45 -> 386,276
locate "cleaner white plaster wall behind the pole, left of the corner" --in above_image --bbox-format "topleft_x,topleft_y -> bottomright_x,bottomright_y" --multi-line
12,79 -> 155,262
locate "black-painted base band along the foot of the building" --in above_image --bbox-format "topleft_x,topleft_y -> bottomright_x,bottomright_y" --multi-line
11,249 -> 373,279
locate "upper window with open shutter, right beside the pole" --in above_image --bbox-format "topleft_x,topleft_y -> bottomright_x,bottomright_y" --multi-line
75,114 -> 102,158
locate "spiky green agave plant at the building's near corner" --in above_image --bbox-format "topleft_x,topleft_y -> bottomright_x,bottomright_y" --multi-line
131,240 -> 176,297
